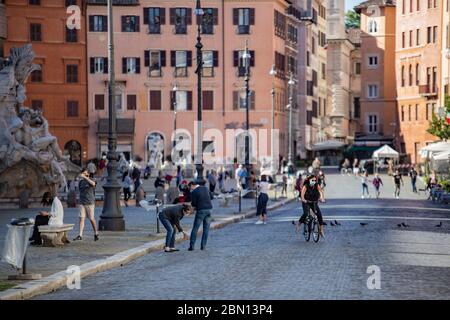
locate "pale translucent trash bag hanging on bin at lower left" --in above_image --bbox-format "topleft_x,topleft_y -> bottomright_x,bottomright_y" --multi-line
2,224 -> 33,269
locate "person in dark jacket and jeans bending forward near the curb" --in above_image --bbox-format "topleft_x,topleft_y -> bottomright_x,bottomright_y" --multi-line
158,204 -> 192,252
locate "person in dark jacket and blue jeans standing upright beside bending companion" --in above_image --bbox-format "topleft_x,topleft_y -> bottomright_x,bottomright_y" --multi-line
189,181 -> 212,251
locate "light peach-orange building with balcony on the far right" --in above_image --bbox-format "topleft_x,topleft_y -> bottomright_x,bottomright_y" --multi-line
396,0 -> 445,163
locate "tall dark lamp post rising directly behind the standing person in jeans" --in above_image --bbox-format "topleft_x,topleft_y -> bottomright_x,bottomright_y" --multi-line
195,0 -> 206,185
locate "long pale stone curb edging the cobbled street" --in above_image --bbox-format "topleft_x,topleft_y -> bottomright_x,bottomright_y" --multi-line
0,199 -> 295,300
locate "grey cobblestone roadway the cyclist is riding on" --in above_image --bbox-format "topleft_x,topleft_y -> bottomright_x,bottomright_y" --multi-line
38,175 -> 450,299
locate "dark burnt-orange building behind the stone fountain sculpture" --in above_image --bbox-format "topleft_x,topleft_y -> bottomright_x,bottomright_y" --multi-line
4,0 -> 88,165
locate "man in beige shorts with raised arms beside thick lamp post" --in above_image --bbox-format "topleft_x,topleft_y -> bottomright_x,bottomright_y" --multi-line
73,168 -> 99,241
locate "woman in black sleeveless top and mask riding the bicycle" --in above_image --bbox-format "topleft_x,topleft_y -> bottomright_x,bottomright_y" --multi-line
298,175 -> 325,236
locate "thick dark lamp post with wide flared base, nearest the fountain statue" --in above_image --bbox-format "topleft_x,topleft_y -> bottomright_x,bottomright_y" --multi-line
99,0 -> 125,231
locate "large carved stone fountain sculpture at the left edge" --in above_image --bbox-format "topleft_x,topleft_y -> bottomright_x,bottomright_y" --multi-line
0,44 -> 75,203
